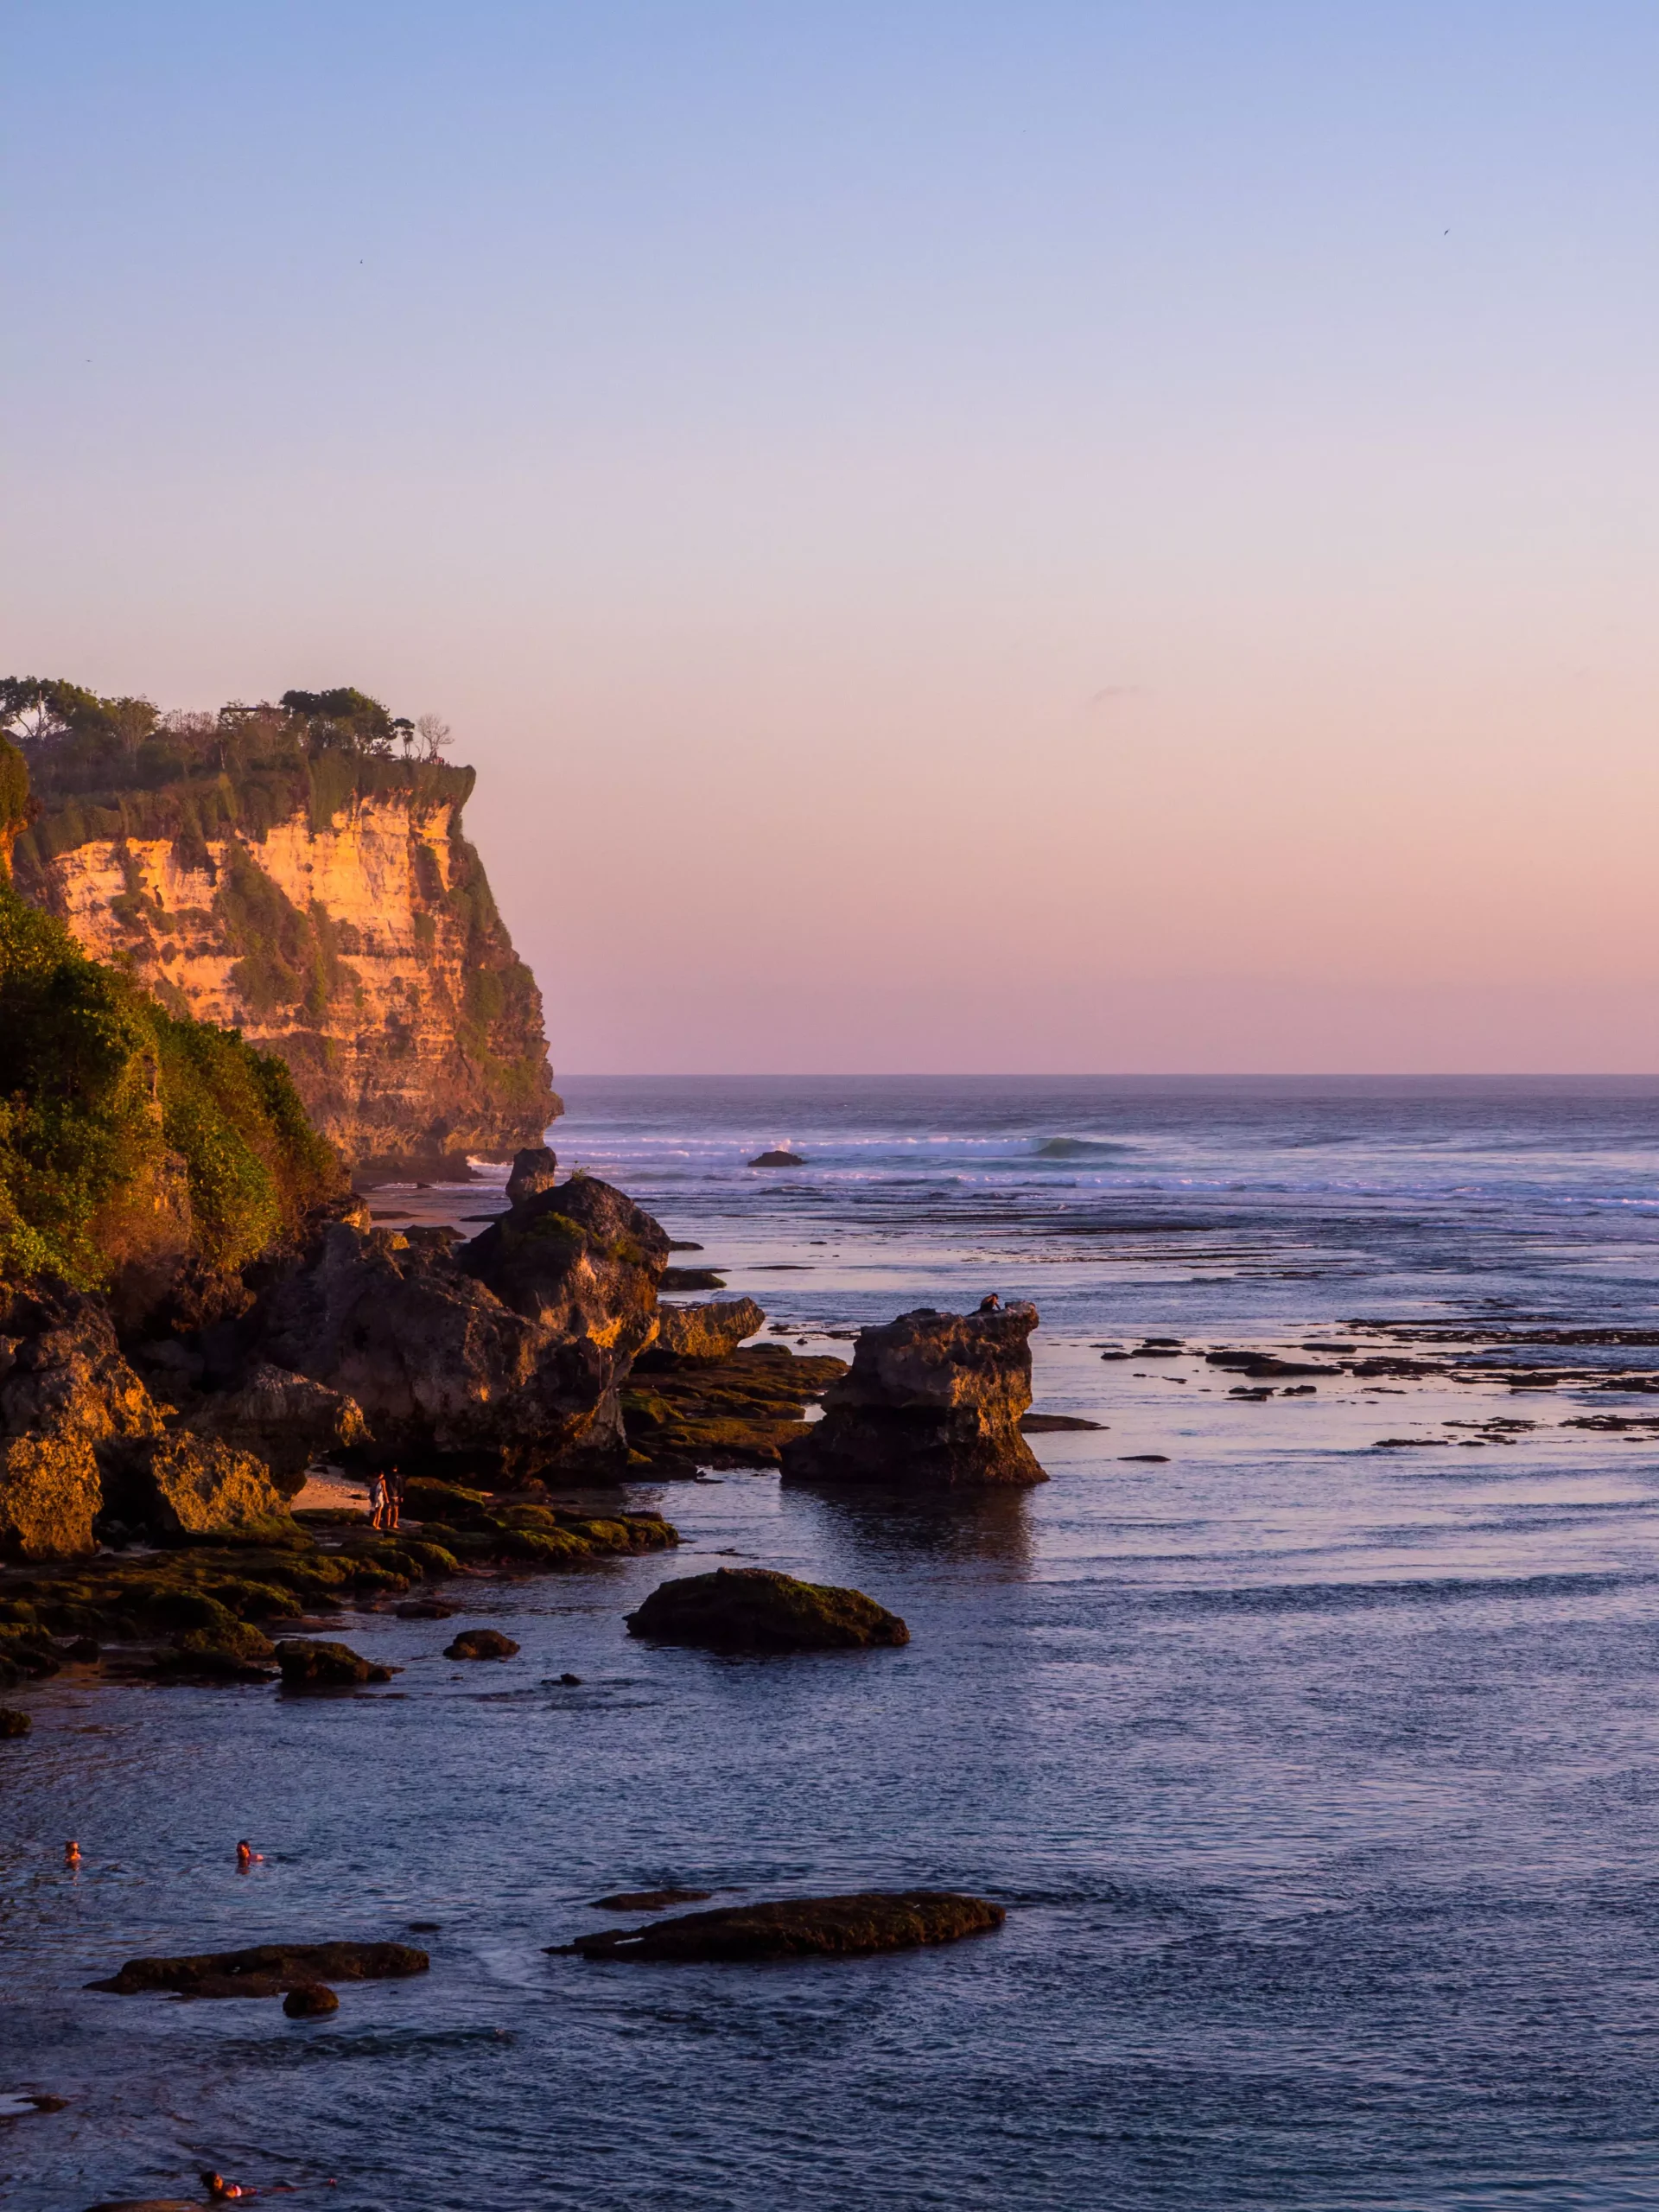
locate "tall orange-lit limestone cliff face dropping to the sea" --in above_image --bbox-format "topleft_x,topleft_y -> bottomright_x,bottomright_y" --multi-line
13,757 -> 560,1170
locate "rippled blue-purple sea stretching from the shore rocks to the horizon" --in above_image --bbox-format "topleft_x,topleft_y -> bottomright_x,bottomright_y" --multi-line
0,1079 -> 1659,2212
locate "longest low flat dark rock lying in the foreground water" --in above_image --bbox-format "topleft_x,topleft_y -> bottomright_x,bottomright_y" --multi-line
560,1889 -> 1007,1964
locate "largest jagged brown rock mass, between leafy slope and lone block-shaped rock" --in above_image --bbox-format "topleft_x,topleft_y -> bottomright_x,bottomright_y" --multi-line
248,1177 -> 668,1482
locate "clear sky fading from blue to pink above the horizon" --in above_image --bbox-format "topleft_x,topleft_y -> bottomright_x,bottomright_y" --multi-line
0,0 -> 1659,1073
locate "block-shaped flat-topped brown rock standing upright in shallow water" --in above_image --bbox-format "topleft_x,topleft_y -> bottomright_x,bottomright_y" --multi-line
783,1305 -> 1048,1489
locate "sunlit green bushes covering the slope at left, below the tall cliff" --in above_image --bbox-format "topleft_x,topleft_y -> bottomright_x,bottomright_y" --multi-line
0,739 -> 343,1289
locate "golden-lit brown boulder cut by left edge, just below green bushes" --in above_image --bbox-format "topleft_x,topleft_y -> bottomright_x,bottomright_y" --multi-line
0,1283 -> 162,1560
